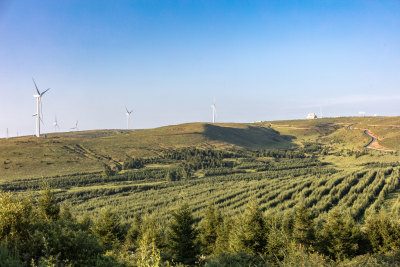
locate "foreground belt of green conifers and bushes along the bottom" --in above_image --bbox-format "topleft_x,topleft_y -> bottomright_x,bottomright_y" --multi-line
0,189 -> 400,266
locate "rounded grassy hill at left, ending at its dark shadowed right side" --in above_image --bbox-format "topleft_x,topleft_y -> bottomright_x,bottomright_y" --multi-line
0,123 -> 294,180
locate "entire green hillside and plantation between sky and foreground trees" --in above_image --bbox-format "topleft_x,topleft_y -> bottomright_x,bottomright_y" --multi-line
0,117 -> 400,266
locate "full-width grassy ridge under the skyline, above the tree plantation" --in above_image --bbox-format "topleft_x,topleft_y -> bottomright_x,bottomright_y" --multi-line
0,117 -> 400,182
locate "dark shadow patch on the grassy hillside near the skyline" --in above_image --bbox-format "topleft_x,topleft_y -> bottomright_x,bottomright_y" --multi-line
204,124 -> 296,149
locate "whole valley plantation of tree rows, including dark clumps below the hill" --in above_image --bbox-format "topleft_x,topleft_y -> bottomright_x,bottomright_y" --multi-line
0,147 -> 400,226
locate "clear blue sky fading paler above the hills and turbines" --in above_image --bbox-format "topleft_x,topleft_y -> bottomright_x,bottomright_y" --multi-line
0,0 -> 400,137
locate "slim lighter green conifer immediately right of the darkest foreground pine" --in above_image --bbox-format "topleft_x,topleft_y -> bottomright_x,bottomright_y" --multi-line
200,205 -> 223,255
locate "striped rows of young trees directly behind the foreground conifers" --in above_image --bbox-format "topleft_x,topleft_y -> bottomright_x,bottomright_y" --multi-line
18,167 -> 394,224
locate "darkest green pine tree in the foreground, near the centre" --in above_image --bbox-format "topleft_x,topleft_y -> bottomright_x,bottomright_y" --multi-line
168,204 -> 199,264
